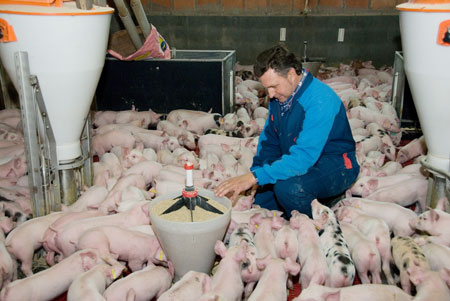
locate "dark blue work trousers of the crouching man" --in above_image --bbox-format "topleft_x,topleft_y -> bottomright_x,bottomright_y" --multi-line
254,153 -> 359,219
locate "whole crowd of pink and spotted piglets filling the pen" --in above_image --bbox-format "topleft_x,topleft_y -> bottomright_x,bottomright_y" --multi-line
0,62 -> 450,300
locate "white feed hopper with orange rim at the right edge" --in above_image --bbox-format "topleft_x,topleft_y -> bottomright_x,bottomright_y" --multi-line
397,0 -> 450,207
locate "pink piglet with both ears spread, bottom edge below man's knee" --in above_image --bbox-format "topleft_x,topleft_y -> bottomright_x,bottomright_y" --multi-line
248,256 -> 300,301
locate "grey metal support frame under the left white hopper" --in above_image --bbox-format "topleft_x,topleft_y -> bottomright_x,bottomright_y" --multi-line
14,52 -> 92,216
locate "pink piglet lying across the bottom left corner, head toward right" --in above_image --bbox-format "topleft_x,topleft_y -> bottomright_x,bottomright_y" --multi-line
1,249 -> 103,301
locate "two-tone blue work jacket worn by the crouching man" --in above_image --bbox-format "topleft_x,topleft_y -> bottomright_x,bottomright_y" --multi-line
250,72 -> 355,185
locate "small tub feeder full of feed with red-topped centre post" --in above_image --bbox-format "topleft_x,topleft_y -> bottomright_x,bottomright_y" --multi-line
150,163 -> 232,281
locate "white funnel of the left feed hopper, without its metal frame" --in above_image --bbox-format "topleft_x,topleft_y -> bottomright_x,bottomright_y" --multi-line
0,0 -> 114,162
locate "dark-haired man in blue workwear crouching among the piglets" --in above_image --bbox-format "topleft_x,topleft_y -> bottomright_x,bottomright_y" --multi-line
215,45 -> 359,218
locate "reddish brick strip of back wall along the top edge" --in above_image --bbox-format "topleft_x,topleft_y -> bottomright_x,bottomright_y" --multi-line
142,0 -> 407,16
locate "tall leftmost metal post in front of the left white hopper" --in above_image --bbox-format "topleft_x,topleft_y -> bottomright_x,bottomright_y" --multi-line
14,52 -> 46,217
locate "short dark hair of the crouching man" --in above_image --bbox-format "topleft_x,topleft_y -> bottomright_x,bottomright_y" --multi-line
253,44 -> 302,77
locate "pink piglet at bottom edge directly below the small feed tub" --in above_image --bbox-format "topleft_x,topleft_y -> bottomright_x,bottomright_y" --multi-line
158,271 -> 211,301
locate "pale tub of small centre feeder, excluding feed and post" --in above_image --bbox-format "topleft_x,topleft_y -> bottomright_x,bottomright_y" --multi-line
150,189 -> 232,281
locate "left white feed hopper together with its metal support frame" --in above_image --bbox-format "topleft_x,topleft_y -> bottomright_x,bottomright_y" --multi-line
0,0 -> 114,216
